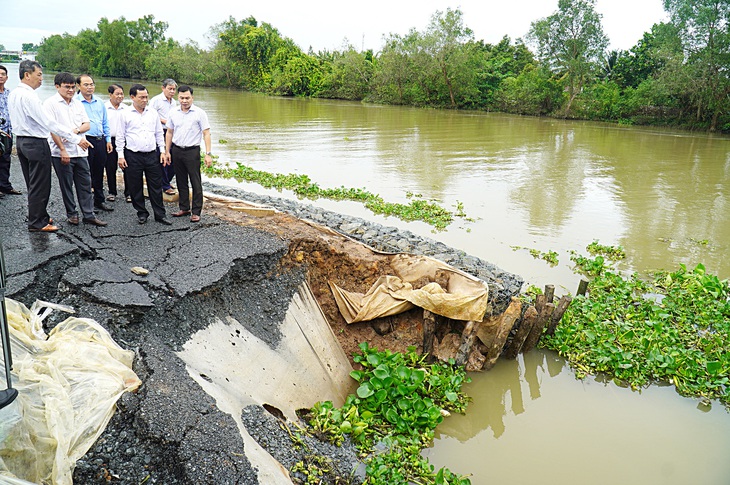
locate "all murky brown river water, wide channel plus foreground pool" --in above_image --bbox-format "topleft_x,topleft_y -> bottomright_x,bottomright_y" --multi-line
8,65 -> 730,485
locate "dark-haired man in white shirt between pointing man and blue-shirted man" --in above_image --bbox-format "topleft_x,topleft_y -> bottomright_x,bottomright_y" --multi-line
43,72 -> 107,226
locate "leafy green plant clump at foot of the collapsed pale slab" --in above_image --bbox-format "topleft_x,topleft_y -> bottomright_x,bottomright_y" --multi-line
307,343 -> 471,485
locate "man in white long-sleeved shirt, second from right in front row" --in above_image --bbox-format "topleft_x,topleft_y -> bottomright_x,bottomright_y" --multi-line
116,84 -> 171,226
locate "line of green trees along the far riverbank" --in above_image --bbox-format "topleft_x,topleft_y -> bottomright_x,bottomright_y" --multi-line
37,0 -> 730,132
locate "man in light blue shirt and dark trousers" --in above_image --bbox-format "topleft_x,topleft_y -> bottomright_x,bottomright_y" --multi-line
76,74 -> 114,211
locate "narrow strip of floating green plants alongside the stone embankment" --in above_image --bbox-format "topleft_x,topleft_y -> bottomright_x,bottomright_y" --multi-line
202,163 -> 466,231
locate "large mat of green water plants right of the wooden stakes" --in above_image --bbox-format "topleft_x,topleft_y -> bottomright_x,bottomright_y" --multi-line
541,243 -> 730,406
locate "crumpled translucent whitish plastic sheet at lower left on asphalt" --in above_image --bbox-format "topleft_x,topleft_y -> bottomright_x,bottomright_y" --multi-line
0,298 -> 141,485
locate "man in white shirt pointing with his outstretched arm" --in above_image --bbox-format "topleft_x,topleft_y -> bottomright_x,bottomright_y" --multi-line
8,60 -> 91,232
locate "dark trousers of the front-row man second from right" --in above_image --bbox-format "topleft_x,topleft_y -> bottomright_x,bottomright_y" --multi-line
124,148 -> 165,219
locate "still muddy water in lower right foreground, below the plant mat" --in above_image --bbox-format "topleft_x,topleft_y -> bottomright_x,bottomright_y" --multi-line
425,350 -> 730,485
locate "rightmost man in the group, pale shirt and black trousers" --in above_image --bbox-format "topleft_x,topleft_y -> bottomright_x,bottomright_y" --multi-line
165,84 -> 213,222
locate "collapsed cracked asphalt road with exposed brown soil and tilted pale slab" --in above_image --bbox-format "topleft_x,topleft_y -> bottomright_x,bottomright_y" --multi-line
0,164 -> 521,485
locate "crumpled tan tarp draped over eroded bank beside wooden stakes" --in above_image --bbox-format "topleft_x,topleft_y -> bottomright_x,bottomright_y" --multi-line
329,254 -> 488,324
